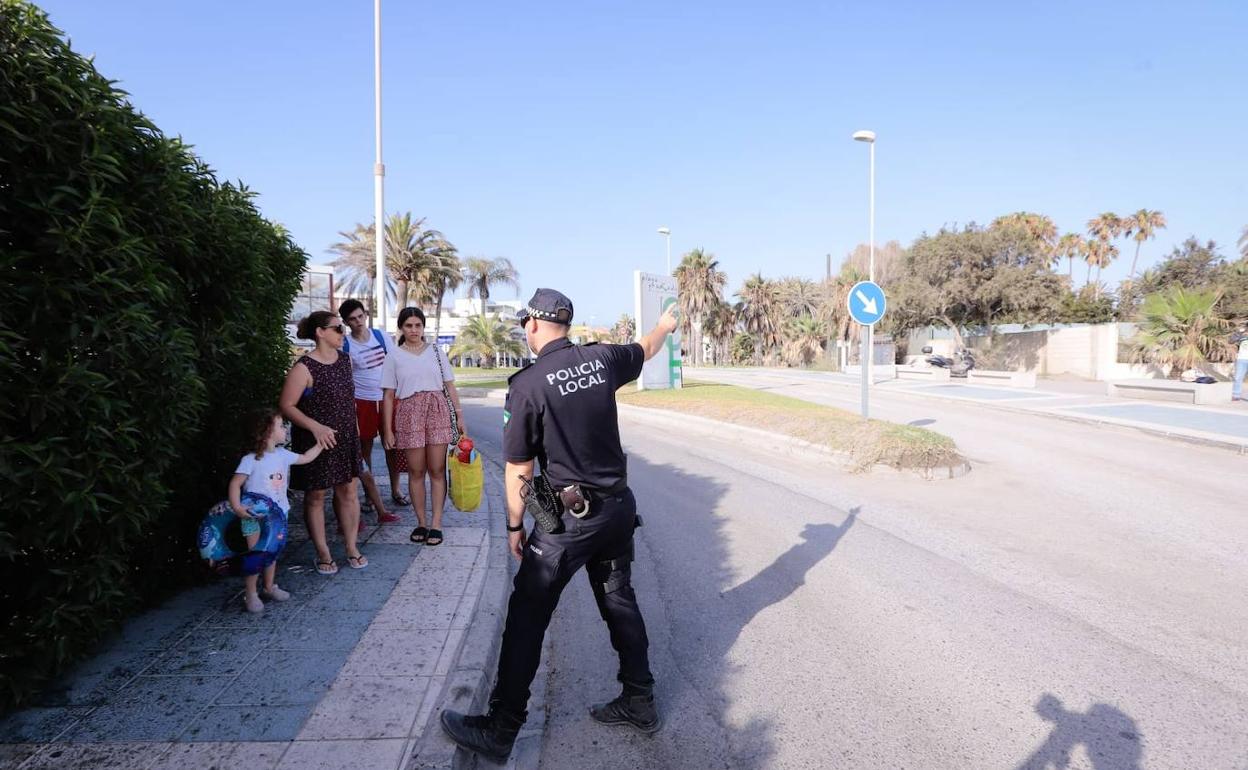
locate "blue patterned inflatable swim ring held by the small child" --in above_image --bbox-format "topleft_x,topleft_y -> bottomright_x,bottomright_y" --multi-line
198,492 -> 286,575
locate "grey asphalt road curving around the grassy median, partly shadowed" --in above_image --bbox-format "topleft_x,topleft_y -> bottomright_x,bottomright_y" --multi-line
469,382 -> 1248,770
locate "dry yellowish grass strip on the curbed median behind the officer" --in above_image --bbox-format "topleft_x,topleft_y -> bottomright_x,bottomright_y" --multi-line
618,382 -> 965,470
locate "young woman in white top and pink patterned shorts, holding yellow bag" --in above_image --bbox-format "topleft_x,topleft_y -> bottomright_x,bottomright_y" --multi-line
382,307 -> 464,545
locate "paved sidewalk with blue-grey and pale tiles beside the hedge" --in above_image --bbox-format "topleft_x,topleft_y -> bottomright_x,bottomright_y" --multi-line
0,431 -> 516,770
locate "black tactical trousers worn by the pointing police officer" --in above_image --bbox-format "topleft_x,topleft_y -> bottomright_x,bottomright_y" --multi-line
490,488 -> 654,718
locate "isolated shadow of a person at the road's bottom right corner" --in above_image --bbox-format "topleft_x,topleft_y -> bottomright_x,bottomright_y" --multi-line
1017,693 -> 1142,770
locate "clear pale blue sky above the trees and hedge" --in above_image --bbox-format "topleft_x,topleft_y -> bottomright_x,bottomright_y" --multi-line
42,0 -> 1248,323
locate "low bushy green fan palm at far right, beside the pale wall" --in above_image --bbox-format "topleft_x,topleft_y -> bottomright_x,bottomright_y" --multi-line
1132,286 -> 1231,377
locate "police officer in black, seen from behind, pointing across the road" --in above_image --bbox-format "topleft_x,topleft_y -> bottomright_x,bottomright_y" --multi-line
442,288 -> 676,761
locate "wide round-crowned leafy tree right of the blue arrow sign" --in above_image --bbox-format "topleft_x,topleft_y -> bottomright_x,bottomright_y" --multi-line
890,225 -> 1062,346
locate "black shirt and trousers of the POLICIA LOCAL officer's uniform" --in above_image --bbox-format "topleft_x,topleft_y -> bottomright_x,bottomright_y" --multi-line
490,338 -> 654,720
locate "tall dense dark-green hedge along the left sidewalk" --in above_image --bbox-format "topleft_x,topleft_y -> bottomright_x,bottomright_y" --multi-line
0,0 -> 307,710
